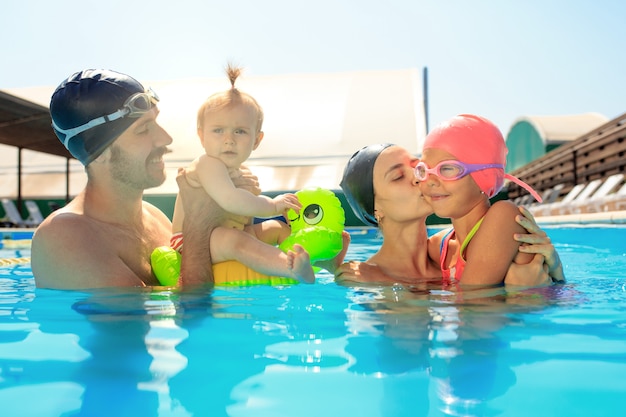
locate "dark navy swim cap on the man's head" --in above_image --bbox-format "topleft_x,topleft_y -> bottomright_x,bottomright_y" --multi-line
50,69 -> 145,166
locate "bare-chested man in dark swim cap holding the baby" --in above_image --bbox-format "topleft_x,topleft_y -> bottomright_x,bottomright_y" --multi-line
31,69 -> 254,289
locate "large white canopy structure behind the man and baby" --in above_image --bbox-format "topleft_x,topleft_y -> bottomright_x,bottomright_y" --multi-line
0,69 -> 426,197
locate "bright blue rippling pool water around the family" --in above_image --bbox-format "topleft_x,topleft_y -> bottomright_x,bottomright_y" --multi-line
0,227 -> 626,417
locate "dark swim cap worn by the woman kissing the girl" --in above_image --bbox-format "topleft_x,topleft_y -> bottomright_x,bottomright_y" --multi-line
339,143 -> 393,226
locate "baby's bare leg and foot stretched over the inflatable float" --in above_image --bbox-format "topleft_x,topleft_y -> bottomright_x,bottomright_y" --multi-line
211,227 -> 315,284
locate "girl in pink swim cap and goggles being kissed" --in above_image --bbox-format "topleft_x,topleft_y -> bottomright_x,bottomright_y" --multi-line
415,114 -> 552,285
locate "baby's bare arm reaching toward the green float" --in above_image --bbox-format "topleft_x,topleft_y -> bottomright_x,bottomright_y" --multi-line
190,155 -> 300,217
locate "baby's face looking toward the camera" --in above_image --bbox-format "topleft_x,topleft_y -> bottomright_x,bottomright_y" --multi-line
198,105 -> 263,169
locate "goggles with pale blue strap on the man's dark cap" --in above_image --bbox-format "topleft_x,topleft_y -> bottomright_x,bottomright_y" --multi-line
52,88 -> 159,148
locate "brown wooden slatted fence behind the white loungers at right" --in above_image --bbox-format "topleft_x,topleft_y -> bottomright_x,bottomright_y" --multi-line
508,113 -> 626,199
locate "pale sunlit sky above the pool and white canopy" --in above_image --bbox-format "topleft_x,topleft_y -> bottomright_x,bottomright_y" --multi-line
0,0 -> 626,133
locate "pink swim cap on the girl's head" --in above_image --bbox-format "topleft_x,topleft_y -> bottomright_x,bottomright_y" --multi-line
423,114 -> 541,202
